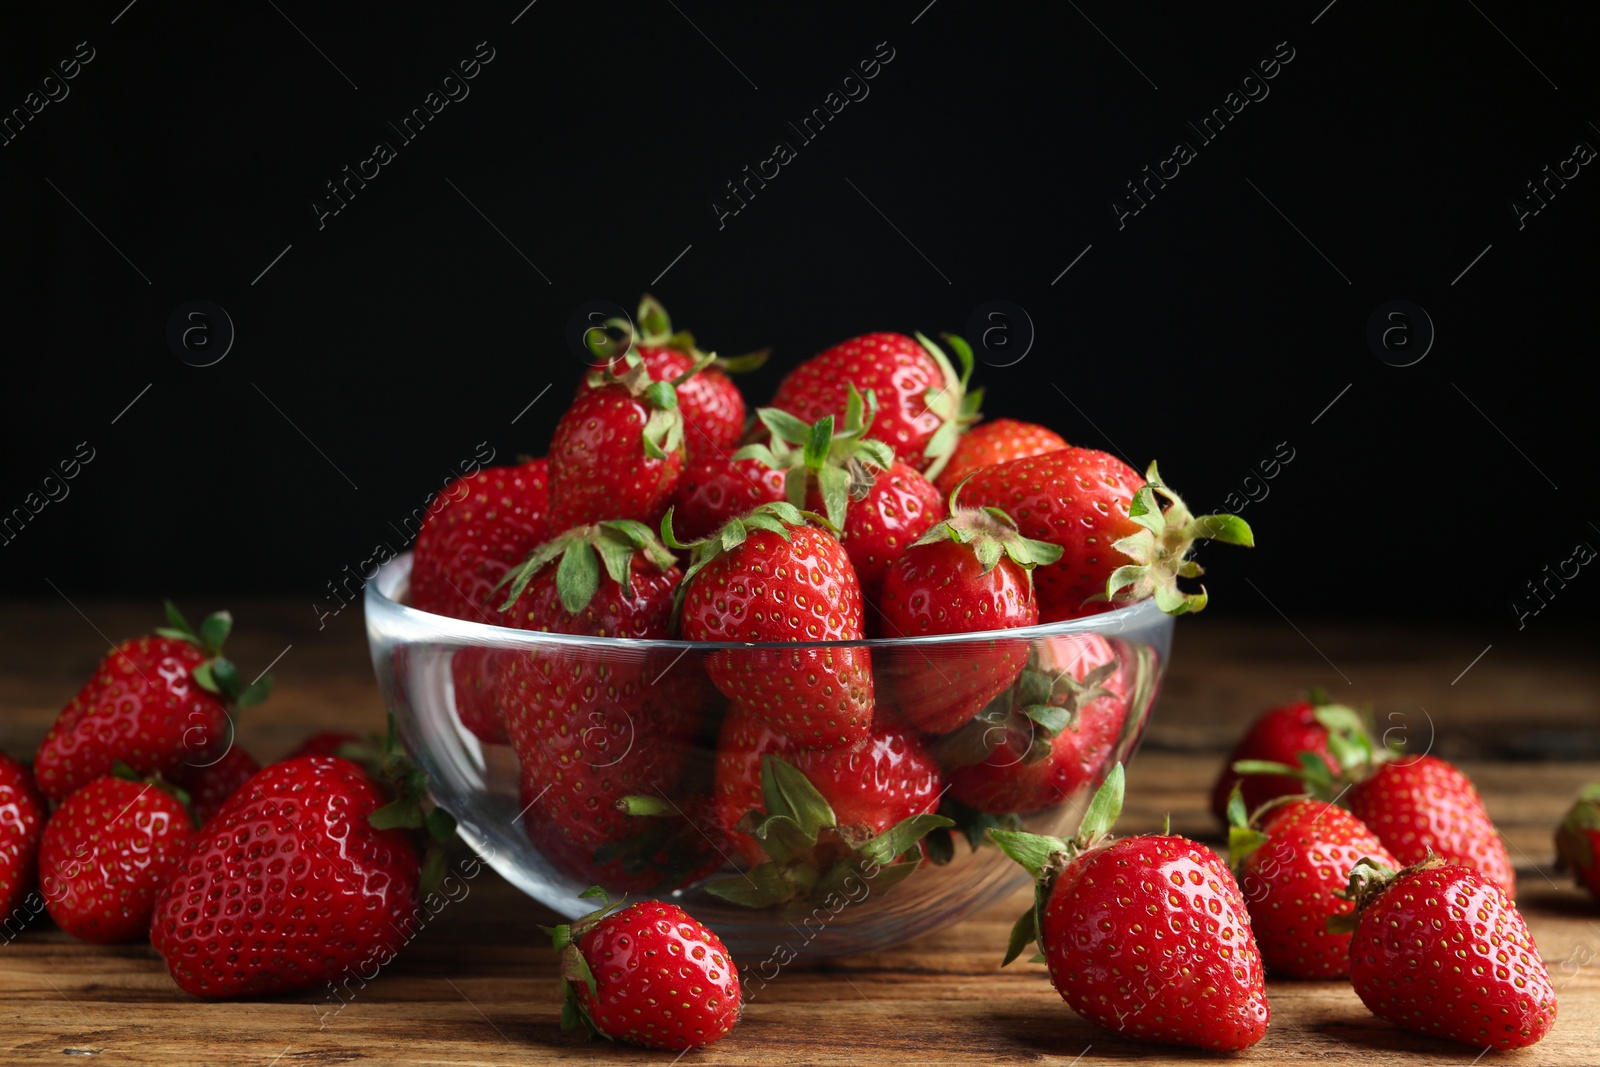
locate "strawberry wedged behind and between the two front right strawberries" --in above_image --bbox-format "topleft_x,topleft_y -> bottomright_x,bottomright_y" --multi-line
1227,793 -> 1395,979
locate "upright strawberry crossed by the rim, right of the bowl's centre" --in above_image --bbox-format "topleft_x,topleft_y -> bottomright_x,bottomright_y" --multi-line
878,498 -> 1061,734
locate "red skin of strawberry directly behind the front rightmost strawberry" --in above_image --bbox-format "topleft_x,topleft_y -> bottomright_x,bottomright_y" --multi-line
1346,755 -> 1517,897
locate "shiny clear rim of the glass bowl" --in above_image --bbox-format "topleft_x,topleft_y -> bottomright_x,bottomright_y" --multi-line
363,552 -> 1176,653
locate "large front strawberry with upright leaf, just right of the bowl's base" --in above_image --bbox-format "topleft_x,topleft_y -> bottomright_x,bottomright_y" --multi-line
989,763 -> 1269,1051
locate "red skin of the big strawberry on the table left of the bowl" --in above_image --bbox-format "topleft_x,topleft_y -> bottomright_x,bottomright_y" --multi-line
150,755 -> 421,998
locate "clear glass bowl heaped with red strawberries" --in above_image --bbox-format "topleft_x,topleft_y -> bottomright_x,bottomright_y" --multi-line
365,298 -> 1251,969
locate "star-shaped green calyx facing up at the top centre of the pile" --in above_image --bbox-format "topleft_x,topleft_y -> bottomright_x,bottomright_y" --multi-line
733,382 -> 894,528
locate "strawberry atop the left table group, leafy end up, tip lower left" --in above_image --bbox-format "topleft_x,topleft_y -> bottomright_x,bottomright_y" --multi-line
34,601 -> 272,801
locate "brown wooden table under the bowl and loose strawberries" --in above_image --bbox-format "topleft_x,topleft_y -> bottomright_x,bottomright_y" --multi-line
0,601 -> 1600,1067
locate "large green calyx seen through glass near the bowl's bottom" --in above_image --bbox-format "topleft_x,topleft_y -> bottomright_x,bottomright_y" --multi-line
706,755 -> 955,913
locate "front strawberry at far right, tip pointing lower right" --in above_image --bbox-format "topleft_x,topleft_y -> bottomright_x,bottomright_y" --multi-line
1349,857 -> 1555,1051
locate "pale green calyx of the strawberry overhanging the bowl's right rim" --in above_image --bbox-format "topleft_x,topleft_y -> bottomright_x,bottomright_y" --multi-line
1096,462 -> 1256,614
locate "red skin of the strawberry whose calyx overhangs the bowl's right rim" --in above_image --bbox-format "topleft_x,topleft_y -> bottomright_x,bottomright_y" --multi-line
960,448 -> 1144,622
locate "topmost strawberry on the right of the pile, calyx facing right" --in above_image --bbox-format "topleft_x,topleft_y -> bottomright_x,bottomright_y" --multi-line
773,333 -> 982,478
